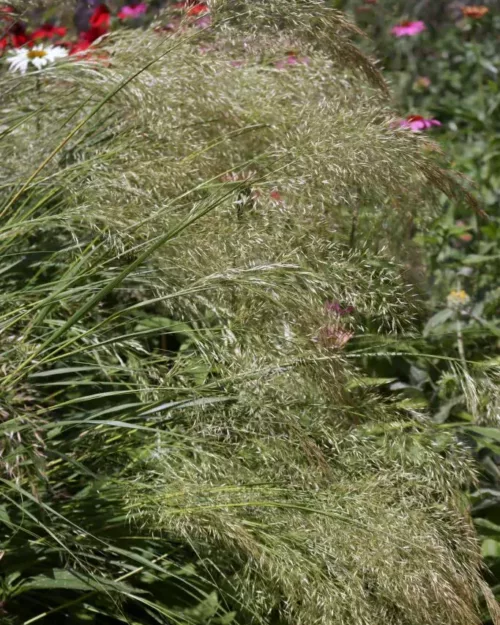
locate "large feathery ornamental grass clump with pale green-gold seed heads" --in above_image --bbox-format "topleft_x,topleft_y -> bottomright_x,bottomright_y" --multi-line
0,2 -> 492,625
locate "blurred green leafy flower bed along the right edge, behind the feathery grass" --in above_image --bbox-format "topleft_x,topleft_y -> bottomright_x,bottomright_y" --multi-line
326,0 -> 500,616
